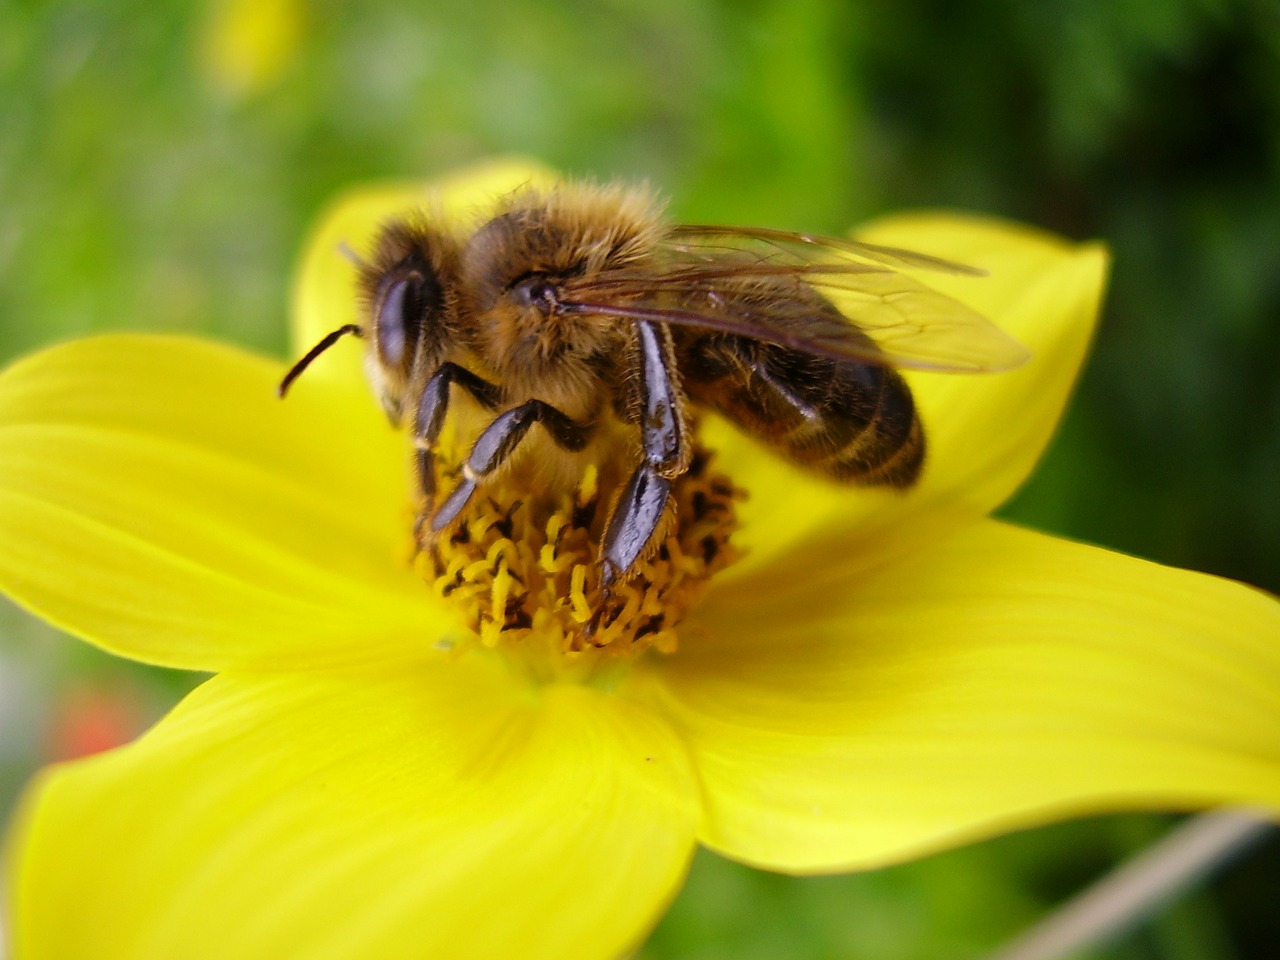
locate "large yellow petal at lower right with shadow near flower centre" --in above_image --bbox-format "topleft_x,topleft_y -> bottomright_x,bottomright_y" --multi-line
654,520 -> 1280,872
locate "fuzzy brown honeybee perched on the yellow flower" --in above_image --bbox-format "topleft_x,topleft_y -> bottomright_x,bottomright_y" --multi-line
279,184 -> 1027,590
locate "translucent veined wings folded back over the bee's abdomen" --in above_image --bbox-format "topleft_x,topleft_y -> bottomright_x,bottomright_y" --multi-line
561,227 -> 1029,372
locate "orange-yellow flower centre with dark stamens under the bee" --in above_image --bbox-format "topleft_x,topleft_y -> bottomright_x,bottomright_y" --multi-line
415,448 -> 744,675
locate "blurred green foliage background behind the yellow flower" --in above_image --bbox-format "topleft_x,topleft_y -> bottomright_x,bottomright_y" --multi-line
0,0 -> 1280,960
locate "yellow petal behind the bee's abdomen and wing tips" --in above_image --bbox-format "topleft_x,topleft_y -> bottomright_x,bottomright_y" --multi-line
708,214 -> 1107,573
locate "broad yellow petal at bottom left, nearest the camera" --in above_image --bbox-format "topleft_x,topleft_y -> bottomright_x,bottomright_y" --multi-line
12,658 -> 696,960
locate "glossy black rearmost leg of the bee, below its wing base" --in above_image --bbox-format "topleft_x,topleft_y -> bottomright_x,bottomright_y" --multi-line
600,320 -> 692,589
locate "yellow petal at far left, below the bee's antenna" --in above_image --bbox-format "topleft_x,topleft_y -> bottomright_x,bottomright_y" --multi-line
0,337 -> 442,669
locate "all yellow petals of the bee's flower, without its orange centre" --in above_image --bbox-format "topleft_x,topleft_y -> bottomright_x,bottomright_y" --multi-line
0,165 -> 1280,960
